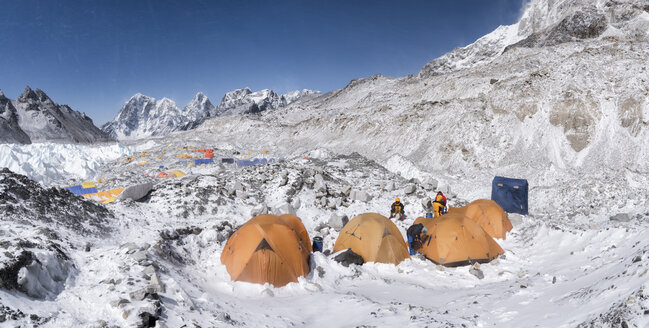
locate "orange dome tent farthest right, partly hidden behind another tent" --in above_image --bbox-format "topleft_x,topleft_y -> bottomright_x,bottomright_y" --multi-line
451,199 -> 513,239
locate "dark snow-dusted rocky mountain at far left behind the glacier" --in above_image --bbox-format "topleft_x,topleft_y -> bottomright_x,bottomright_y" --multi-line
5,86 -> 112,143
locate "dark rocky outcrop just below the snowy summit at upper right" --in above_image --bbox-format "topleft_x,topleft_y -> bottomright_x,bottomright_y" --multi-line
504,8 -> 608,52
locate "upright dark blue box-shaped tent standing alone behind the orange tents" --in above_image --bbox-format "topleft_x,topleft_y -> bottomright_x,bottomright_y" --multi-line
491,176 -> 528,215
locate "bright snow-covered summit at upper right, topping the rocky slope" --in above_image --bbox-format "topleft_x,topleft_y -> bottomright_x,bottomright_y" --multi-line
420,0 -> 649,77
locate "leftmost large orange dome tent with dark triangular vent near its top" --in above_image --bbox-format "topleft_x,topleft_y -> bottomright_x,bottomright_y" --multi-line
221,214 -> 312,287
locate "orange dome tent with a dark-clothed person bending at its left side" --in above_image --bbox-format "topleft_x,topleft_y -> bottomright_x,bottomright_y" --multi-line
413,212 -> 504,267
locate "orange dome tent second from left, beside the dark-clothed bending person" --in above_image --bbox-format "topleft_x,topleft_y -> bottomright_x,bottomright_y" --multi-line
333,213 -> 410,265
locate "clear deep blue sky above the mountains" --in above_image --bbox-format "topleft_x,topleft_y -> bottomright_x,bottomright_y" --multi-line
0,0 -> 524,125
